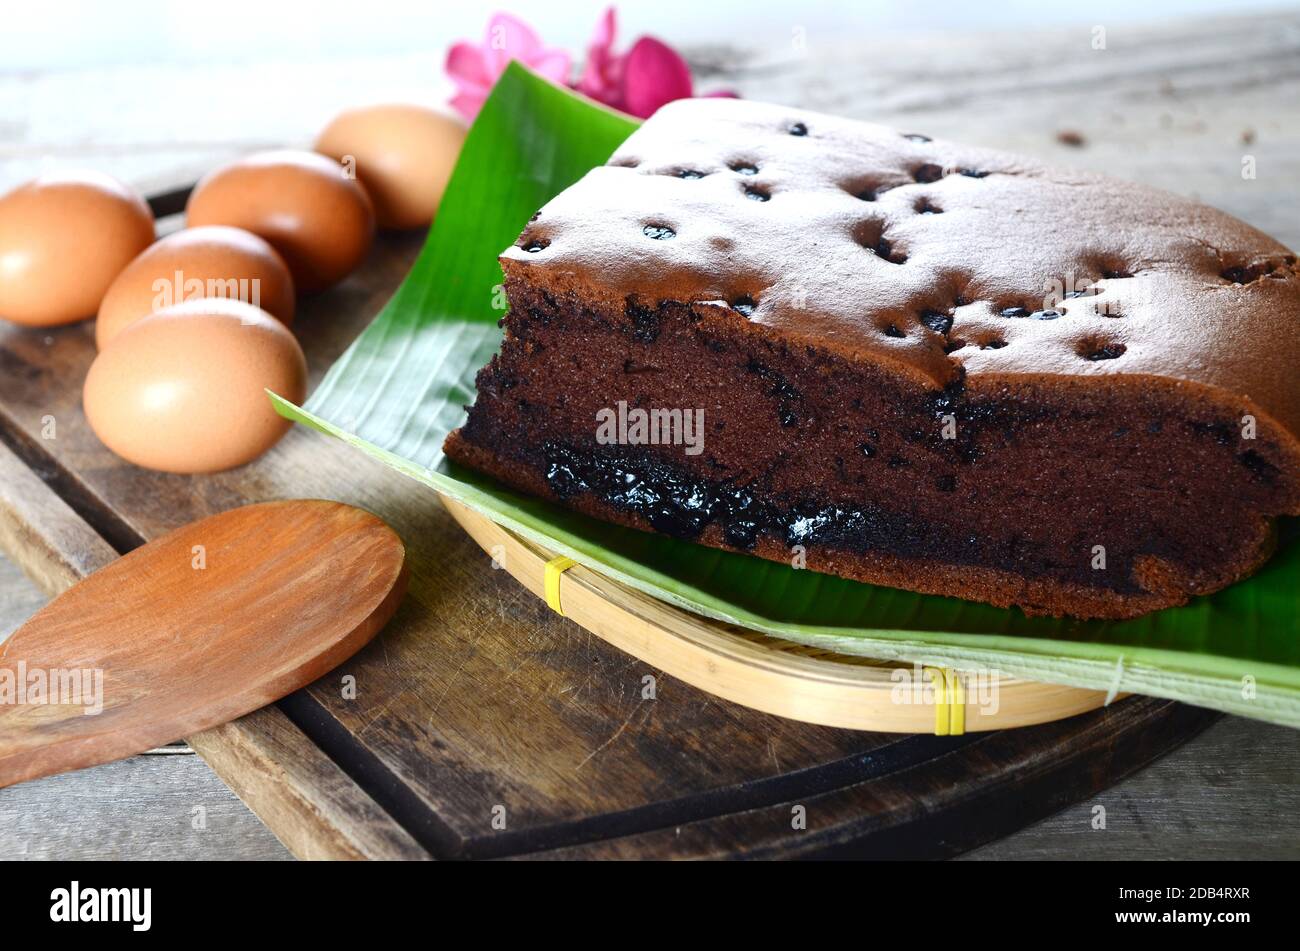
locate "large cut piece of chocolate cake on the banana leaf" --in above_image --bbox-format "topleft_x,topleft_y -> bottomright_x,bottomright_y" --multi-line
446,99 -> 1300,618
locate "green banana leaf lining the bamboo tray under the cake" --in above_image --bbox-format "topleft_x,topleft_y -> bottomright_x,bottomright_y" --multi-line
273,59 -> 1300,726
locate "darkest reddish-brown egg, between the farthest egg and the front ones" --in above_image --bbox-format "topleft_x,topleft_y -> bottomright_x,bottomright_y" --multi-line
185,151 -> 374,292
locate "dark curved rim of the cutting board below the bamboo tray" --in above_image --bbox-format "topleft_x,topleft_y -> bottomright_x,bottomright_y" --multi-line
514,696 -> 1223,861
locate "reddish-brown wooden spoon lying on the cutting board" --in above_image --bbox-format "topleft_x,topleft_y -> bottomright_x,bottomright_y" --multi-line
0,500 -> 407,786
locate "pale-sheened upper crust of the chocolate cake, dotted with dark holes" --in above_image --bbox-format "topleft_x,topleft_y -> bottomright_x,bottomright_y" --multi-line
502,99 -> 1300,446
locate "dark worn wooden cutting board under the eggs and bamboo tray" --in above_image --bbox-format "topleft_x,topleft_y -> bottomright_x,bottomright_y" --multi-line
0,184 -> 1214,857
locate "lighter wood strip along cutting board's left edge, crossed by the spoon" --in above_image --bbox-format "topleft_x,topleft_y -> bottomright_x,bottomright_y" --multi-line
0,443 -> 430,859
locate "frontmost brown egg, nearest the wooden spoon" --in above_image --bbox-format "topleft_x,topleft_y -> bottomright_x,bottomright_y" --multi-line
82,299 -> 307,473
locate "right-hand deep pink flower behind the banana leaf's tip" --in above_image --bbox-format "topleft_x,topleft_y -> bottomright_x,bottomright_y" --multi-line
575,6 -> 735,118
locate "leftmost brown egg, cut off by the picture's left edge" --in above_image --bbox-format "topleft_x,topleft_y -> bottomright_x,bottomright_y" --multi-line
0,171 -> 153,327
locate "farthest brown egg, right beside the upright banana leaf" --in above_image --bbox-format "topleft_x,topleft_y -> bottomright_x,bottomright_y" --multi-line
316,104 -> 465,230
